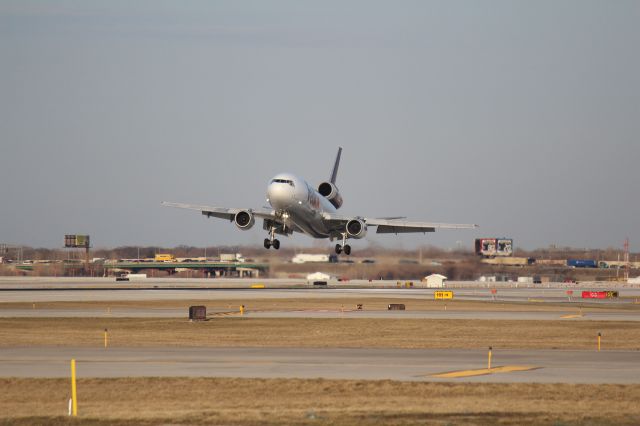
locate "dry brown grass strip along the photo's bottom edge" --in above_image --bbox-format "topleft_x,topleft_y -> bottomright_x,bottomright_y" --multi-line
0,378 -> 640,425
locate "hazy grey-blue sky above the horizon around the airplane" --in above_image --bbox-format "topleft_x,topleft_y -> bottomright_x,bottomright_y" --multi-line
0,0 -> 640,251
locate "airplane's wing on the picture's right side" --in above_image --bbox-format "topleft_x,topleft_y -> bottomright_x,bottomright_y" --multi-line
323,213 -> 478,234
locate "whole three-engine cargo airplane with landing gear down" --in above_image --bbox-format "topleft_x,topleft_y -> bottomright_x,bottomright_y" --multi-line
162,147 -> 478,255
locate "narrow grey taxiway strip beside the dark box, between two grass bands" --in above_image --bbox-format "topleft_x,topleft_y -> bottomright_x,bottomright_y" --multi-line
0,304 -> 640,321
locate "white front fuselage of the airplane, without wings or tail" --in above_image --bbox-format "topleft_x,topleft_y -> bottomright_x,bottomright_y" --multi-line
267,173 -> 336,238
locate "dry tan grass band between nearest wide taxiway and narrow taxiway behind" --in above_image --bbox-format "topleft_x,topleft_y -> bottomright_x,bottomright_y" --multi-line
0,316 -> 640,350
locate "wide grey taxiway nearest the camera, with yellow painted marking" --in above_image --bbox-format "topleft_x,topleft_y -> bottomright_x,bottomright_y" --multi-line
0,347 -> 640,384
